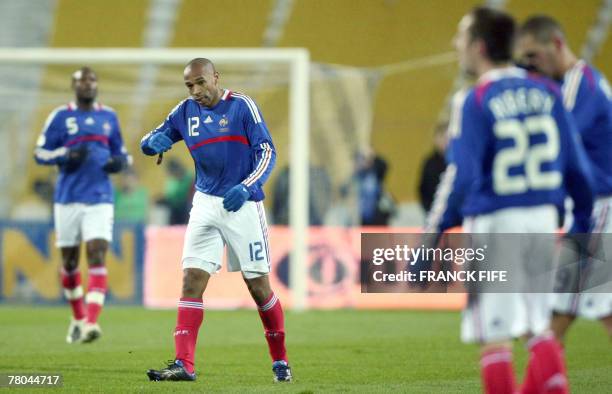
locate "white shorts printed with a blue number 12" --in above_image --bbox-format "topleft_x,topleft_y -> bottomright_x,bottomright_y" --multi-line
182,191 -> 270,279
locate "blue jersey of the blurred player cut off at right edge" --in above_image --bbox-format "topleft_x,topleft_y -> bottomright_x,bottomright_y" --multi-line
562,60 -> 612,196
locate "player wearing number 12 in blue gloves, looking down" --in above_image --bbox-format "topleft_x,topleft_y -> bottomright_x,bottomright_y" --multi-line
141,58 -> 291,381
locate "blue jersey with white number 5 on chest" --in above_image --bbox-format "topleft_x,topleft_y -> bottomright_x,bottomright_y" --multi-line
34,103 -> 129,204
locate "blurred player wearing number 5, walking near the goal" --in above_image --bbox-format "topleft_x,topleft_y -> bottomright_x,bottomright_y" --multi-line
34,67 -> 131,343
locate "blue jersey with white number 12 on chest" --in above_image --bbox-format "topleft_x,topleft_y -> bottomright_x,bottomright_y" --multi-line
140,90 -> 276,201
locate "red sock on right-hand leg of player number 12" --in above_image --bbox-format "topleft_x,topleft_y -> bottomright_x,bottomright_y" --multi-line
258,293 -> 287,361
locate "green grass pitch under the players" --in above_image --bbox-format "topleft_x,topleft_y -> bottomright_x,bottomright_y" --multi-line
0,306 -> 612,394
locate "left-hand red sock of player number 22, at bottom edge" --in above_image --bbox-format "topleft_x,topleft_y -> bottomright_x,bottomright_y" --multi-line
480,348 -> 515,394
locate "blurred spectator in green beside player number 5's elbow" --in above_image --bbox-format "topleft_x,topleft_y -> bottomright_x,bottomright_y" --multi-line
115,168 -> 149,223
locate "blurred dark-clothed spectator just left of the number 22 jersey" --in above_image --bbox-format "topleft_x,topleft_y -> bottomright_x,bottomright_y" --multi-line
419,122 -> 448,214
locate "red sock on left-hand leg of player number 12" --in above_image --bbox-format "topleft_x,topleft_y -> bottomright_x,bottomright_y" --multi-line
174,298 -> 204,373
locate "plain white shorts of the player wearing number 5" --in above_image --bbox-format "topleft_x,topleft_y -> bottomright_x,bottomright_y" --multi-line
53,203 -> 114,248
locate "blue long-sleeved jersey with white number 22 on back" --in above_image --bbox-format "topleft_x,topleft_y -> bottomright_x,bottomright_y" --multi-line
427,67 -> 593,232
